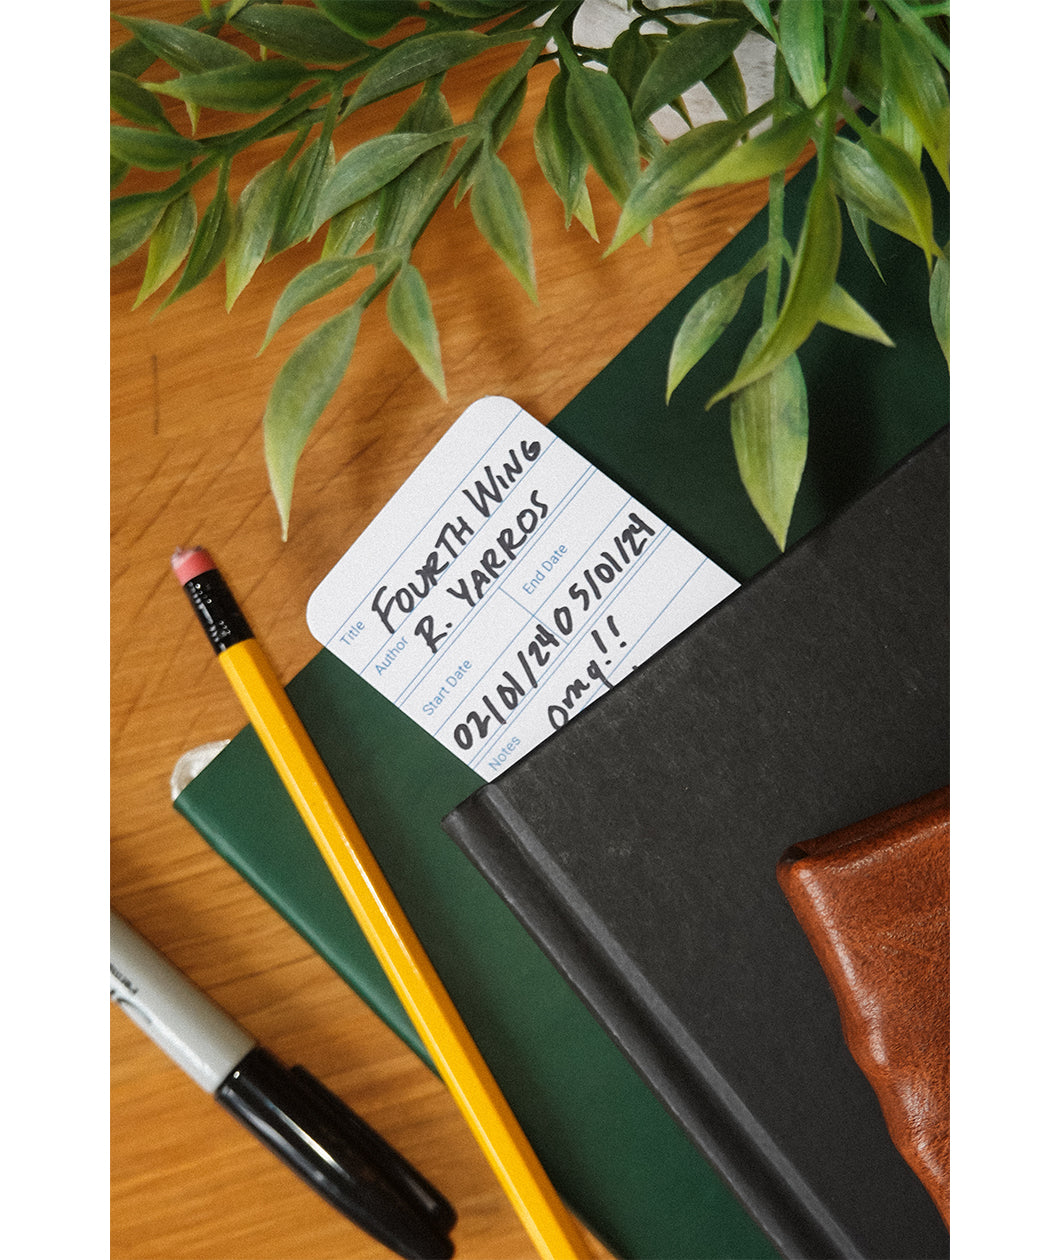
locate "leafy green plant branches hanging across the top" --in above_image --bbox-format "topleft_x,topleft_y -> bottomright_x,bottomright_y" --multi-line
111,0 -> 949,549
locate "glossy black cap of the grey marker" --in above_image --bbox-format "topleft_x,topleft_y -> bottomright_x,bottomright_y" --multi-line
214,1046 -> 456,1260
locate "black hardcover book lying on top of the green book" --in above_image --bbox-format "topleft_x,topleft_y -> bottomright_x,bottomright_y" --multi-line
444,431 -> 949,1260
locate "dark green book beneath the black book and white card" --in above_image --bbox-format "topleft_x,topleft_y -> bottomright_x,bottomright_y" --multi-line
176,160 -> 948,1260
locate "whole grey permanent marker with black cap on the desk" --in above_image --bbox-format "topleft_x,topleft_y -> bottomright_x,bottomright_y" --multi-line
111,910 -> 456,1260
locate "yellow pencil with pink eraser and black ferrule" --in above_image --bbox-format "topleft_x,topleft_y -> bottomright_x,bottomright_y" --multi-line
173,547 -> 591,1260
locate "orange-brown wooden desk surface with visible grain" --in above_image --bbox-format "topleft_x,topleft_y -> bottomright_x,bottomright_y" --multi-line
111,3 -> 765,1260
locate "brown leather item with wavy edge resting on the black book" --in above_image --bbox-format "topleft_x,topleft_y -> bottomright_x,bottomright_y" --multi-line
776,788 -> 949,1225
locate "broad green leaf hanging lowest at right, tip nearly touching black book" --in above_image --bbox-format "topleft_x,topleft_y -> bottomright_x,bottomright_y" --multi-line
730,341 -> 809,551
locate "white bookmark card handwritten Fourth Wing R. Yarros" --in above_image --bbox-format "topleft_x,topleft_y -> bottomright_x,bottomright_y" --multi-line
308,397 -> 739,780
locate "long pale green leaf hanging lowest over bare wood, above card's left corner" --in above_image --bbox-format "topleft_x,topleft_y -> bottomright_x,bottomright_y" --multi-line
263,304 -> 360,542
